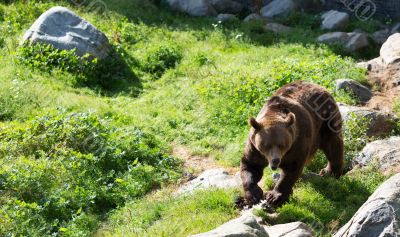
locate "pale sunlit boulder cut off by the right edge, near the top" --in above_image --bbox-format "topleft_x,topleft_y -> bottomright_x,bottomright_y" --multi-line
380,33 -> 400,65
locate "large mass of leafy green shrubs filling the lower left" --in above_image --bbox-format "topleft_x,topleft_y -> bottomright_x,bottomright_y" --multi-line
0,111 -> 180,236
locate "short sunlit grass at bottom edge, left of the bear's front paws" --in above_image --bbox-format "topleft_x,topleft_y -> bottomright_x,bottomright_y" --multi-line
95,189 -> 238,237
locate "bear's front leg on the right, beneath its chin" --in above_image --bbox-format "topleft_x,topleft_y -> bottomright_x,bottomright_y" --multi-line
264,164 -> 303,207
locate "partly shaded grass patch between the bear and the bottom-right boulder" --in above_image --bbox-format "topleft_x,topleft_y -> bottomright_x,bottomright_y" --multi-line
261,168 -> 387,236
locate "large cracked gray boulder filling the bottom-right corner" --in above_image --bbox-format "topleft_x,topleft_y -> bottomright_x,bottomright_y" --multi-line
334,174 -> 400,237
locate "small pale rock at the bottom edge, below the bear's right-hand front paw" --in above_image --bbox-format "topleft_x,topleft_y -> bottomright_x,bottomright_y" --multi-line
265,222 -> 313,237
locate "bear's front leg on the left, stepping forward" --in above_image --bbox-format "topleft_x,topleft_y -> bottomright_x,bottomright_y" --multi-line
240,158 -> 265,205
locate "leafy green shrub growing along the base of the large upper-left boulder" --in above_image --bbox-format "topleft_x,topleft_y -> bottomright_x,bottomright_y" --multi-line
17,44 -> 140,95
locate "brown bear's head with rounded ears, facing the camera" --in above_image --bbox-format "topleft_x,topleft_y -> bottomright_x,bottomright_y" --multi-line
249,112 -> 296,170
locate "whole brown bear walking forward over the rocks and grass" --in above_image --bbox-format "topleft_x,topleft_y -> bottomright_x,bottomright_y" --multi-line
240,81 -> 344,207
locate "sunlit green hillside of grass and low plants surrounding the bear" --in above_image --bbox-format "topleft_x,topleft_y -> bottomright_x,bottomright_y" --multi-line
0,0 -> 396,236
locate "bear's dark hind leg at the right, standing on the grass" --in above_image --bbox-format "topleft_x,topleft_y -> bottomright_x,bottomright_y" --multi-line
320,132 -> 344,178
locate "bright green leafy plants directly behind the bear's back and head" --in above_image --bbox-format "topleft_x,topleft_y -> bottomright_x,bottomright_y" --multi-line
197,56 -> 360,126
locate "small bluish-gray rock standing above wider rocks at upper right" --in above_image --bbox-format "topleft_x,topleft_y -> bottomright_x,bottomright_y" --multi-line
321,10 -> 350,30
